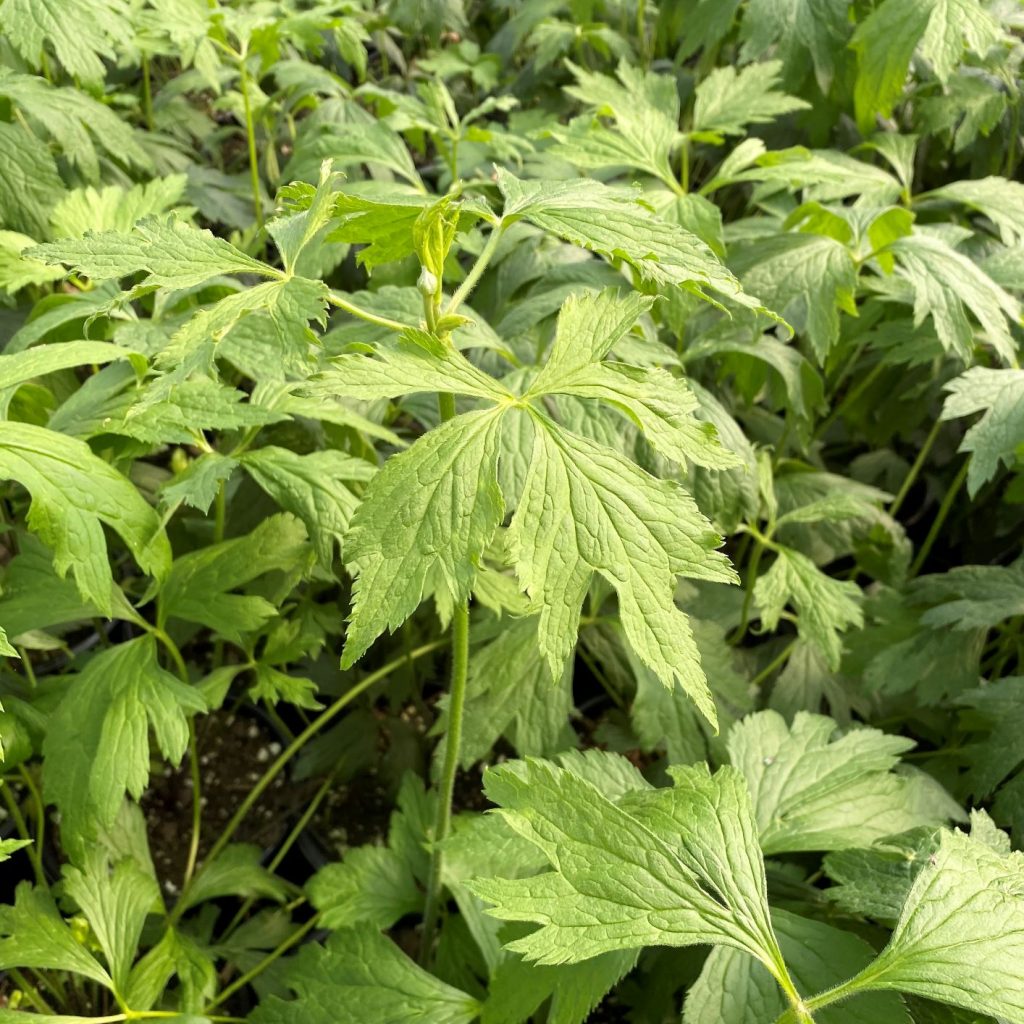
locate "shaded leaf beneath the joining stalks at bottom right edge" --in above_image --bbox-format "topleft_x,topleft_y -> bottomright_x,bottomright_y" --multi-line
683,910 -> 910,1024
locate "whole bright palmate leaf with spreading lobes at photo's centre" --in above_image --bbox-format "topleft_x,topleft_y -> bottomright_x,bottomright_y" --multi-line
329,293 -> 735,722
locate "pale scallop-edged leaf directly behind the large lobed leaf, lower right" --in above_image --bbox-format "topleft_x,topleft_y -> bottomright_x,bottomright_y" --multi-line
728,711 -> 962,854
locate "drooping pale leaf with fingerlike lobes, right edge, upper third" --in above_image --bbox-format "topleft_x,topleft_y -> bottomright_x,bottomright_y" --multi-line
889,232 -> 1021,362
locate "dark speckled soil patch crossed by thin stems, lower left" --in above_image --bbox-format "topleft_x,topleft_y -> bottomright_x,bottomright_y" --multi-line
141,713 -> 308,896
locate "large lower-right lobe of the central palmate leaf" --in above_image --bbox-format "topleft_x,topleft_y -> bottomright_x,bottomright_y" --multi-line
509,413 -> 735,724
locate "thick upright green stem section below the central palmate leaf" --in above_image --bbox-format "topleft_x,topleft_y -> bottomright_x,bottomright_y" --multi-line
420,602 -> 469,964
